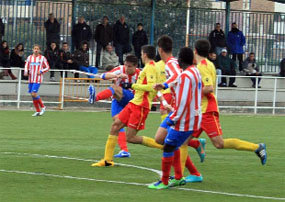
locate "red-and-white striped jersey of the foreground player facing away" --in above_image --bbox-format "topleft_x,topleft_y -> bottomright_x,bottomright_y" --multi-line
170,66 -> 202,132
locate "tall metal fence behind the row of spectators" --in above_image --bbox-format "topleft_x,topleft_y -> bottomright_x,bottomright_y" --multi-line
0,0 -> 285,72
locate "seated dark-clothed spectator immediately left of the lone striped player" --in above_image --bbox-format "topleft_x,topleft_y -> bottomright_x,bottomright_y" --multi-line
10,43 -> 28,80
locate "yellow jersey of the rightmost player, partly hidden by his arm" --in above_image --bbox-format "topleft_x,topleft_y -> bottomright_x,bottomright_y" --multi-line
197,59 -> 219,113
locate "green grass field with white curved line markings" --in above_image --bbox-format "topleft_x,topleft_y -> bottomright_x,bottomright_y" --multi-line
0,111 -> 285,202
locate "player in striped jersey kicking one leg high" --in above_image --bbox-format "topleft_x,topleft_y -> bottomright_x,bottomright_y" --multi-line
88,55 -> 140,158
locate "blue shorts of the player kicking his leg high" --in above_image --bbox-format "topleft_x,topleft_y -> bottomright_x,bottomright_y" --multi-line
111,89 -> 134,117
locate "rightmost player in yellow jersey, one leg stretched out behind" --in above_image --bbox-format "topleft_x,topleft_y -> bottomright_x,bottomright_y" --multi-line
189,40 -> 267,165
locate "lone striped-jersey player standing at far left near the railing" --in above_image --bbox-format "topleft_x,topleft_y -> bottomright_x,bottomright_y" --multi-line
24,45 -> 49,116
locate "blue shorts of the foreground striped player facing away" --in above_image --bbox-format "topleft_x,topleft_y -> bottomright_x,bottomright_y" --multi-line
164,127 -> 193,147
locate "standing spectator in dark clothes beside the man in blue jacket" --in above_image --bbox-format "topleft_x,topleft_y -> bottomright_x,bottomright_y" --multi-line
209,23 -> 227,55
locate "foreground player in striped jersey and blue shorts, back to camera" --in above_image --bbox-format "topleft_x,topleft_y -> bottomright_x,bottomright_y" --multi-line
149,47 -> 202,189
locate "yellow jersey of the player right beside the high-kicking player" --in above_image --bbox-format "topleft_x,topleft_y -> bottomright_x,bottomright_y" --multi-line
130,61 -> 158,109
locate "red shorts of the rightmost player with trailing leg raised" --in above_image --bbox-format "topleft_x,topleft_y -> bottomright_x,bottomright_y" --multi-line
192,112 -> 223,138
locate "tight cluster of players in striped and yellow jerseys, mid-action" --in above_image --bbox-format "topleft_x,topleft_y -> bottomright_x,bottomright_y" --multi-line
88,35 -> 267,189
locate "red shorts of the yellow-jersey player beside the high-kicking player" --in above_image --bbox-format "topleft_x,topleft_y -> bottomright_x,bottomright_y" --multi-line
118,102 -> 149,130
